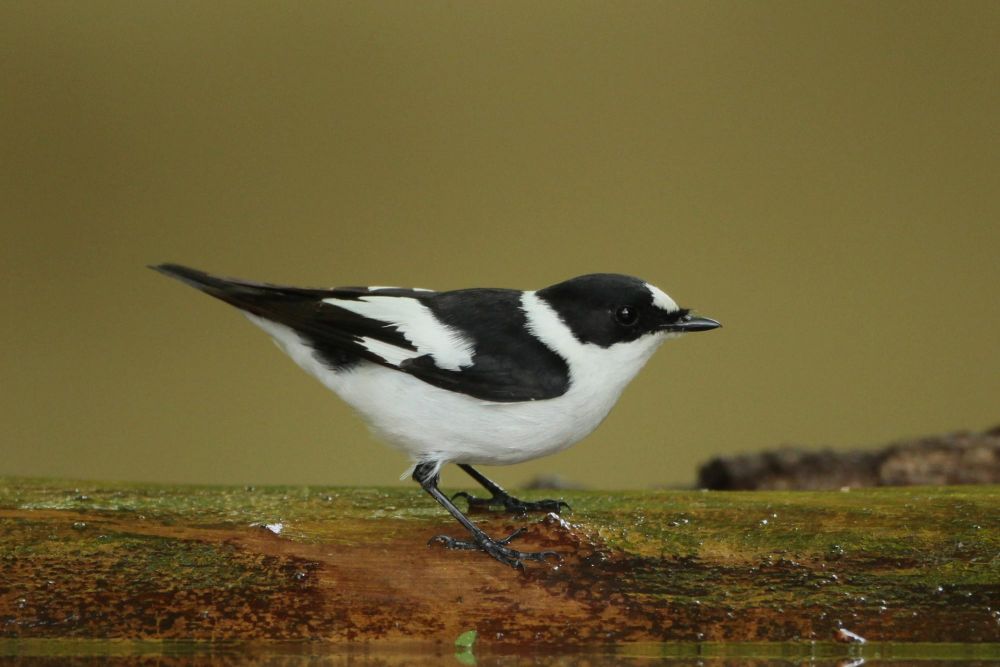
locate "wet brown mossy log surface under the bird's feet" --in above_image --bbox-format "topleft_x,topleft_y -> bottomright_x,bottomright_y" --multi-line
0,479 -> 1000,646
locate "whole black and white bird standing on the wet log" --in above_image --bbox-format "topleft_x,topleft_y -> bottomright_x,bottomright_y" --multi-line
151,264 -> 720,567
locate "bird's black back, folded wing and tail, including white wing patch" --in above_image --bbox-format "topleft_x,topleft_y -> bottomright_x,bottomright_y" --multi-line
151,264 -> 569,402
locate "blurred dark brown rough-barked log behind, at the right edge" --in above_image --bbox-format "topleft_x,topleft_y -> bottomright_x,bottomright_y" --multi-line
698,426 -> 1000,491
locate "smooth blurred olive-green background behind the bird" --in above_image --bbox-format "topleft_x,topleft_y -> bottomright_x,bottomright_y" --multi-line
0,0 -> 1000,487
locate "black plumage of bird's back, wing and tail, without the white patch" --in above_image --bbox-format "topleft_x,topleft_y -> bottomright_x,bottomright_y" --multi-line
150,264 -> 569,402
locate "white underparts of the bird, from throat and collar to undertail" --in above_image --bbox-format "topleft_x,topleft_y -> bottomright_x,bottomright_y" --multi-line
242,292 -> 665,472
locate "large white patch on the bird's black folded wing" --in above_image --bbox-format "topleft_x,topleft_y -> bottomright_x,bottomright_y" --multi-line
323,295 -> 475,371
